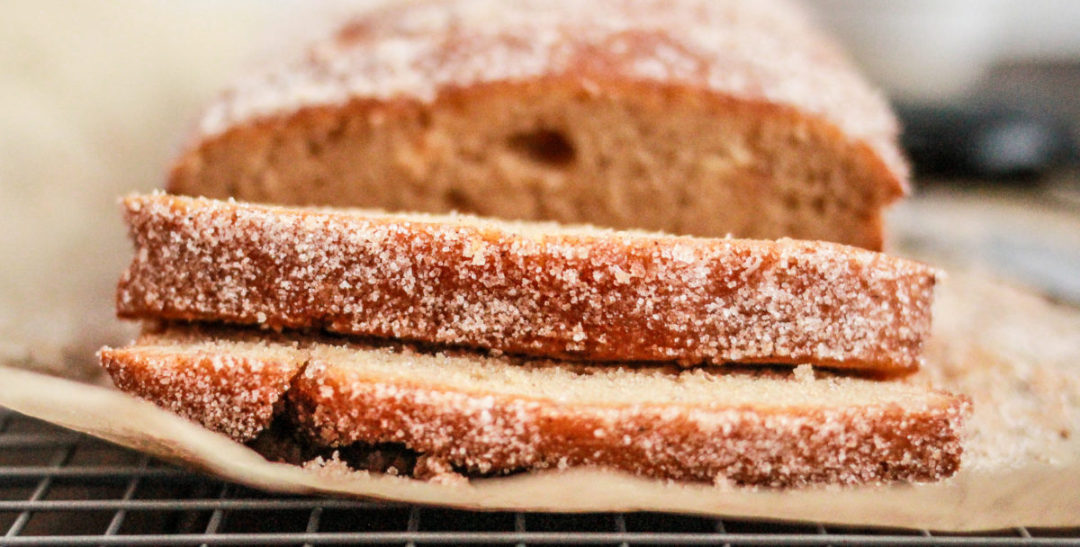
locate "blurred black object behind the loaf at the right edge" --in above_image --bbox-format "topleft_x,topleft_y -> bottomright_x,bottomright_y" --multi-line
897,102 -> 1077,181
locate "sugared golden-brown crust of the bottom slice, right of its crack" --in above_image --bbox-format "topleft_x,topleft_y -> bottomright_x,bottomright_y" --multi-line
288,361 -> 970,486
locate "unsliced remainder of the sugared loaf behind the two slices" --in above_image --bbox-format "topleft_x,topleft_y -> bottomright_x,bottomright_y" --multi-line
168,0 -> 907,250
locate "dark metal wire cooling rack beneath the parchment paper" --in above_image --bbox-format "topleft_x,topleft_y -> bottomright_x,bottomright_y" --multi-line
0,409 -> 1080,547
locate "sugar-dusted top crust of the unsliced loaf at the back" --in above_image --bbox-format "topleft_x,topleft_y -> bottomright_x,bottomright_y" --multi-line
192,0 -> 906,184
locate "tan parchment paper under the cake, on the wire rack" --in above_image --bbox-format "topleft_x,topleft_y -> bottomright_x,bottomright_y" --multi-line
0,276 -> 1080,531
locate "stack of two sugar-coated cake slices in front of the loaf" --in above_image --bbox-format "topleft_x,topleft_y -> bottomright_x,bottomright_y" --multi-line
102,195 -> 968,485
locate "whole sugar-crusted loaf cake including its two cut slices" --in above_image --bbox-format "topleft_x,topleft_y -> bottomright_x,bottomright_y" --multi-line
99,0 -> 970,488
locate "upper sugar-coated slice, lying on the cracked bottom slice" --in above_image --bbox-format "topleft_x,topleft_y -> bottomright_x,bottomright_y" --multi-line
118,195 -> 935,373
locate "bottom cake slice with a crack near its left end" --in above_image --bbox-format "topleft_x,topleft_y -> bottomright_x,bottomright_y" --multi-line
100,328 -> 969,486
